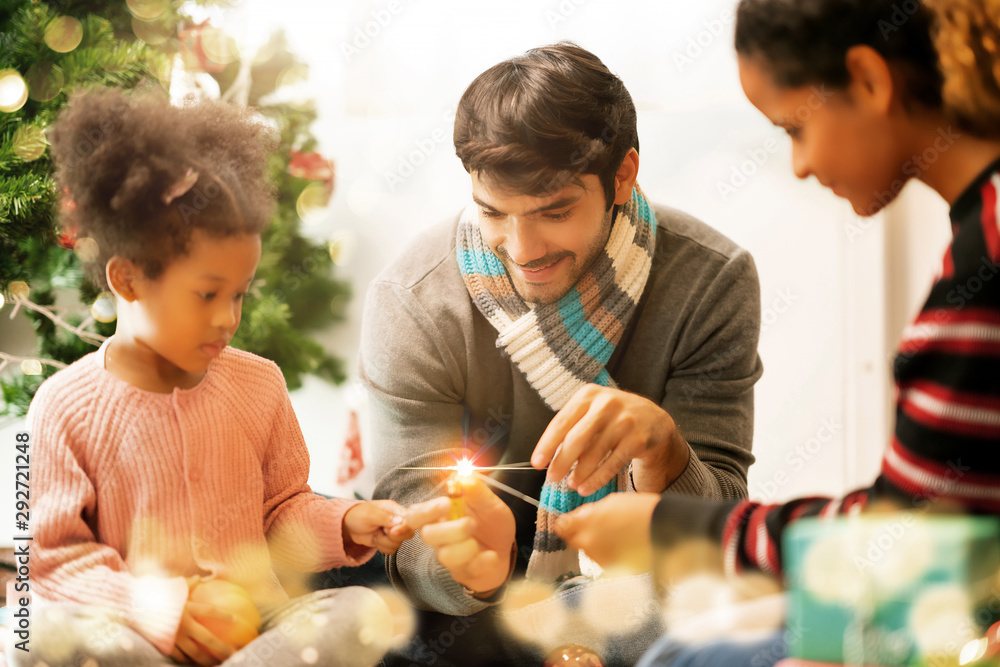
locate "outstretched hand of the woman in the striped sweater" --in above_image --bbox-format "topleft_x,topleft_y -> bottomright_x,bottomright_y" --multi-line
555,493 -> 660,572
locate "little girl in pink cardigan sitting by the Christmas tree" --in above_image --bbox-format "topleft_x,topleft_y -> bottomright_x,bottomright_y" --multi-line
8,91 -> 412,667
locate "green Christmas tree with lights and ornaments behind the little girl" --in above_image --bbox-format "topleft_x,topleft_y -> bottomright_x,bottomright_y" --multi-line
0,0 -> 350,415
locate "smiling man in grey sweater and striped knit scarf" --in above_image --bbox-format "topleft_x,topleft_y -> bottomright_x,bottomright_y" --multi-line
360,43 -> 762,664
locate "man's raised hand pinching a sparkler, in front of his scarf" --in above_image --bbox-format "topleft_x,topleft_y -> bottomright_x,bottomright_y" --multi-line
531,384 -> 688,496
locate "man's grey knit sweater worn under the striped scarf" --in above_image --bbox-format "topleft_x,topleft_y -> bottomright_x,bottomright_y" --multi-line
360,207 -> 762,615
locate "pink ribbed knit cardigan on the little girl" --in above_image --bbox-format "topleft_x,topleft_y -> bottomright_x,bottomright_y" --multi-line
21,343 -> 374,653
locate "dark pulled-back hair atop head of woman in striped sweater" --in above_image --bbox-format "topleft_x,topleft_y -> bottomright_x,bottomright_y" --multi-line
736,0 -> 943,109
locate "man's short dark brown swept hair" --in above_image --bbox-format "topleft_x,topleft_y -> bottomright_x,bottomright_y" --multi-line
455,42 -> 639,209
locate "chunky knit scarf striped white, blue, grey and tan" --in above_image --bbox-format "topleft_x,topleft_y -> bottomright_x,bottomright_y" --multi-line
456,187 -> 656,582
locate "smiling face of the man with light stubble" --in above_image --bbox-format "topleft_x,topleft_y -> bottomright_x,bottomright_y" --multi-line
472,172 -> 613,304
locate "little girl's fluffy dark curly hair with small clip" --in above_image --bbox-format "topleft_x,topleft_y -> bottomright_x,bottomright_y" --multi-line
49,89 -> 277,289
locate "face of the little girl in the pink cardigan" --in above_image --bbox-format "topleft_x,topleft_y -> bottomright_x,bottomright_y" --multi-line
129,229 -> 261,373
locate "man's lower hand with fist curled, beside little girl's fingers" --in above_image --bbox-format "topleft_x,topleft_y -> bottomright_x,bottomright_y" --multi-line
406,479 -> 515,598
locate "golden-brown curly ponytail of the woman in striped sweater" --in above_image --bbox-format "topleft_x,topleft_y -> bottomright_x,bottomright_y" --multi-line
925,0 -> 1000,139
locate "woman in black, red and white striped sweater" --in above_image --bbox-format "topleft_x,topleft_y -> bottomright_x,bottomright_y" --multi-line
561,0 -> 1000,667
